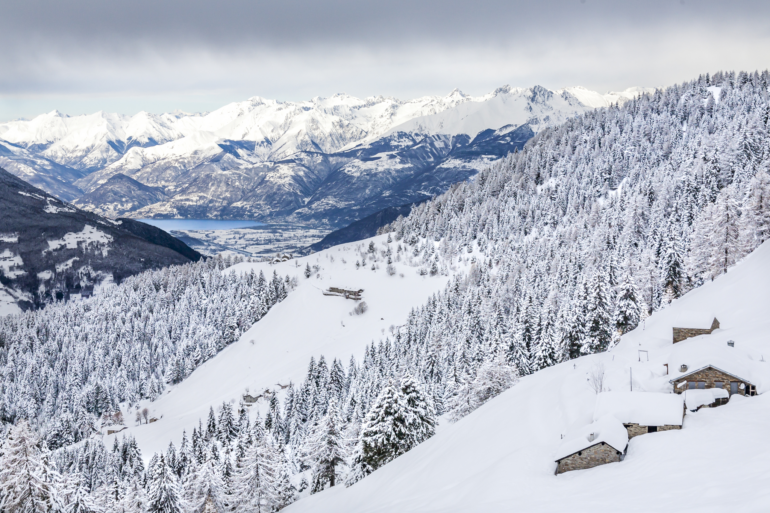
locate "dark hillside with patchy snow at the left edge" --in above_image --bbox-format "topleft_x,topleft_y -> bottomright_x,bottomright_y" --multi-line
0,169 -> 200,313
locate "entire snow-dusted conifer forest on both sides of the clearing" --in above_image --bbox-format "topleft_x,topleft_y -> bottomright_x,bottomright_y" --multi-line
0,71 -> 770,512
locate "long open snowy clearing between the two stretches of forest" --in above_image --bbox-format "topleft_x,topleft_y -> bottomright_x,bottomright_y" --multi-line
104,236 -> 448,459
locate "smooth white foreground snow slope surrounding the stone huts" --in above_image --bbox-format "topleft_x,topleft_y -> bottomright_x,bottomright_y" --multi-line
286,243 -> 770,513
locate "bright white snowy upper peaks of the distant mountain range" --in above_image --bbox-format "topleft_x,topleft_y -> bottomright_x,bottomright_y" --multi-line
0,85 -> 646,176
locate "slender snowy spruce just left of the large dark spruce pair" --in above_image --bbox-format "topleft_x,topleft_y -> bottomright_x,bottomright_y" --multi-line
305,399 -> 347,493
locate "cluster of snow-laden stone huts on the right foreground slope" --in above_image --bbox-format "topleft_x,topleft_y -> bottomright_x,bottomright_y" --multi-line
555,319 -> 757,474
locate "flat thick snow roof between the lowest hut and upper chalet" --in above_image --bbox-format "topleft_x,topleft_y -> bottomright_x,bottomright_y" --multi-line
594,392 -> 684,426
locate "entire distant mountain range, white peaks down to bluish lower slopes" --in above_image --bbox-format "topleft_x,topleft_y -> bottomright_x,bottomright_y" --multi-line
0,86 -> 645,226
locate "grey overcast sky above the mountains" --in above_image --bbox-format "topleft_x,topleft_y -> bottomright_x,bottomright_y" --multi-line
0,0 -> 770,121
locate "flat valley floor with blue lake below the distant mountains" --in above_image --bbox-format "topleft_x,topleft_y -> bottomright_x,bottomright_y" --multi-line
169,224 -> 329,257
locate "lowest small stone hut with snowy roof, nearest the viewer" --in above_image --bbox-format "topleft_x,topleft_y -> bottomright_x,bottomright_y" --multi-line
555,415 -> 628,474
